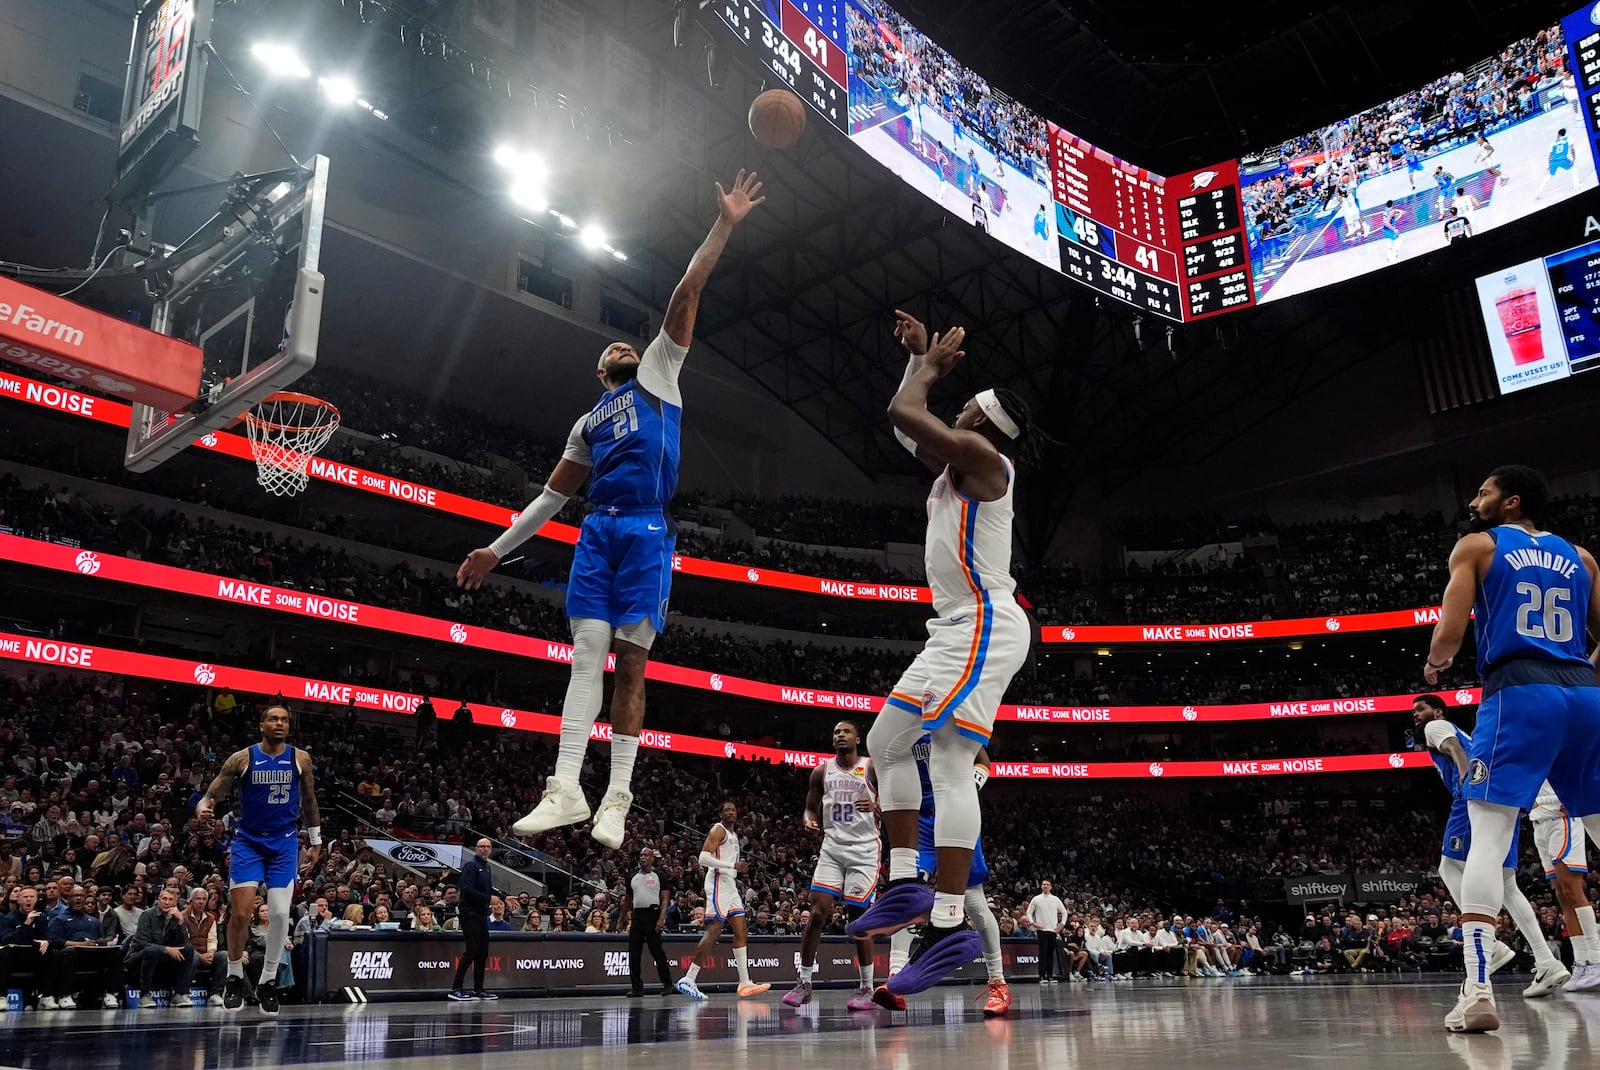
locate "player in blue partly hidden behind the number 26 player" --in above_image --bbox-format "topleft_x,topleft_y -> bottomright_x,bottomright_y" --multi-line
1411,694 -> 1573,1000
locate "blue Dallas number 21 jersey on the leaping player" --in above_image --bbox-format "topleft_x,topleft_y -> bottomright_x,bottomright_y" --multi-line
584,377 -> 683,509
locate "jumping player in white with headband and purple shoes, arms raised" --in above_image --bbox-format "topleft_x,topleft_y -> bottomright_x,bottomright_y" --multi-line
846,312 -> 1037,996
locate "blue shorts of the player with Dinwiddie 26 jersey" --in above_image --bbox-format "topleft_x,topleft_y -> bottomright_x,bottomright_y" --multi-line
1466,683 -> 1600,817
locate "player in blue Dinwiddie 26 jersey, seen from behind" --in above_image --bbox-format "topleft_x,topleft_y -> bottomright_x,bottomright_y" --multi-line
1422,465 -> 1600,1033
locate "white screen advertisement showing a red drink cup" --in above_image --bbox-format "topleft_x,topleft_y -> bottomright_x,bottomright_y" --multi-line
1478,259 -> 1571,393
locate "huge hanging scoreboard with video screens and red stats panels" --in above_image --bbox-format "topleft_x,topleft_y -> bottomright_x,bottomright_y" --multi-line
715,0 -> 1600,323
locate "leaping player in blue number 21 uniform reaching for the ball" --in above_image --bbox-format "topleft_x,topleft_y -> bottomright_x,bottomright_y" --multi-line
456,171 -> 766,848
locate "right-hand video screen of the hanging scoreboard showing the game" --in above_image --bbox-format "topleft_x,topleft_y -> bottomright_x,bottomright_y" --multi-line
1240,26 -> 1595,302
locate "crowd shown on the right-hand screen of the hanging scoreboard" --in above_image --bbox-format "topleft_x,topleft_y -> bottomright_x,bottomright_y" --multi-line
1243,26 -> 1576,246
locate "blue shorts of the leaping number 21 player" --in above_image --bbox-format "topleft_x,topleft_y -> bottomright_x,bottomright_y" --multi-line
566,510 -> 678,635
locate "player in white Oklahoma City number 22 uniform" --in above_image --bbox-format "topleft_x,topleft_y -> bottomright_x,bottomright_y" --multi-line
784,721 -> 882,1011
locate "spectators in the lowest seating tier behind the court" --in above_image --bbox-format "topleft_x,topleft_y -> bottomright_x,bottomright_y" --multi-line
0,669 -> 1593,1009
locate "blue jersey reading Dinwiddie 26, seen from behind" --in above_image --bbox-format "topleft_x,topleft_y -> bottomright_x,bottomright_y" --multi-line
1474,525 -> 1589,673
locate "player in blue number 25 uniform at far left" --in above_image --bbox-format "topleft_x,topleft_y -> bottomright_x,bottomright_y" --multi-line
195,705 -> 322,1016
